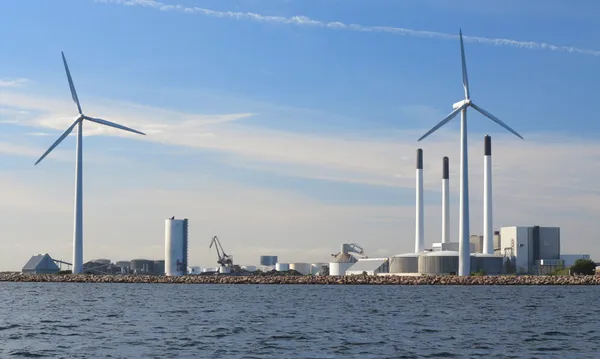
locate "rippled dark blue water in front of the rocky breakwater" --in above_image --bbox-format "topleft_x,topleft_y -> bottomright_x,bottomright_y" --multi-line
0,283 -> 600,359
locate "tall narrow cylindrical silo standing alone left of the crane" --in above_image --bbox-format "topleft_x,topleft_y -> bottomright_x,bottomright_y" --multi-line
165,218 -> 188,276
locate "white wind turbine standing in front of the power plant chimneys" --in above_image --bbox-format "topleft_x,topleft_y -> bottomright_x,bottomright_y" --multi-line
417,30 -> 523,276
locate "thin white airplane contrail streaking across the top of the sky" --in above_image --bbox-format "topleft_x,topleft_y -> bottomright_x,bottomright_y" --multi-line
95,0 -> 600,56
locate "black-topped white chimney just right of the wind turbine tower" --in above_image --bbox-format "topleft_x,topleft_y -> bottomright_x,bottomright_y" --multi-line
483,135 -> 494,254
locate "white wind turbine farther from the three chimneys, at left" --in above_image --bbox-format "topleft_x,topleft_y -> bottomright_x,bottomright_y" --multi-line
35,51 -> 145,274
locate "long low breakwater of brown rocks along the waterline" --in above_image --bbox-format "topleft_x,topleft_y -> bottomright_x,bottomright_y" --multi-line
0,273 -> 600,285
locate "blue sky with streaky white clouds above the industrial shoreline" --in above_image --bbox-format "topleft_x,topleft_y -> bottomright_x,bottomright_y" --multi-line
0,0 -> 600,269
